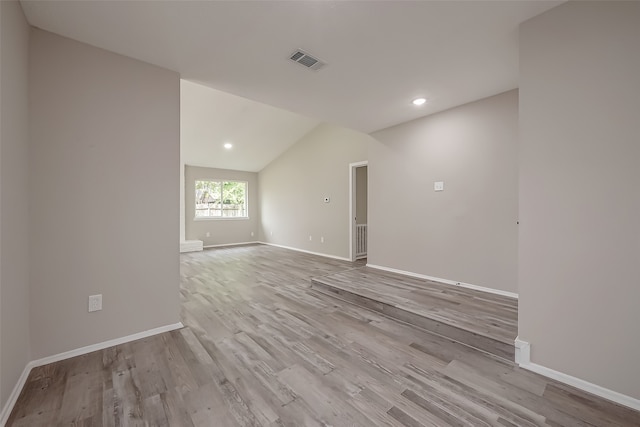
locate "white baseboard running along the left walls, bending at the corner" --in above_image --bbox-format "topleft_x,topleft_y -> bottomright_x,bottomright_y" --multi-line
0,322 -> 184,427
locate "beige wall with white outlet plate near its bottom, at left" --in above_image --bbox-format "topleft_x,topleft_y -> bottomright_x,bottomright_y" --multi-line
29,29 -> 180,359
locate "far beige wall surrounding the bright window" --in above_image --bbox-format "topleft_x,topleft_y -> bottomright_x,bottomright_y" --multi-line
184,165 -> 260,246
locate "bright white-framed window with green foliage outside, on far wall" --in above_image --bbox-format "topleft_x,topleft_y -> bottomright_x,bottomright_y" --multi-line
196,181 -> 248,219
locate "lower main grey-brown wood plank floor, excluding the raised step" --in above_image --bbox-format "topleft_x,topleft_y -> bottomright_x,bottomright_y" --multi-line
8,245 -> 640,427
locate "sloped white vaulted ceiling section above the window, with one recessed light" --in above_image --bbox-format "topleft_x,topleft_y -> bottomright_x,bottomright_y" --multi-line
180,80 -> 320,172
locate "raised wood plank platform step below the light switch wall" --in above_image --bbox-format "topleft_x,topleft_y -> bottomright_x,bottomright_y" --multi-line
311,267 -> 518,361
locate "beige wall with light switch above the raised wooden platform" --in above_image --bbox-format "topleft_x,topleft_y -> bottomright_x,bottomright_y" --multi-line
368,90 -> 518,293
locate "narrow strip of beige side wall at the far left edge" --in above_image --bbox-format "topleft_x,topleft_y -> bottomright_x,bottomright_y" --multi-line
0,1 -> 30,409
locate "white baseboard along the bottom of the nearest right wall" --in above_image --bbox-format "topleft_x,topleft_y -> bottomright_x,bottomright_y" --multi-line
516,337 -> 640,411
